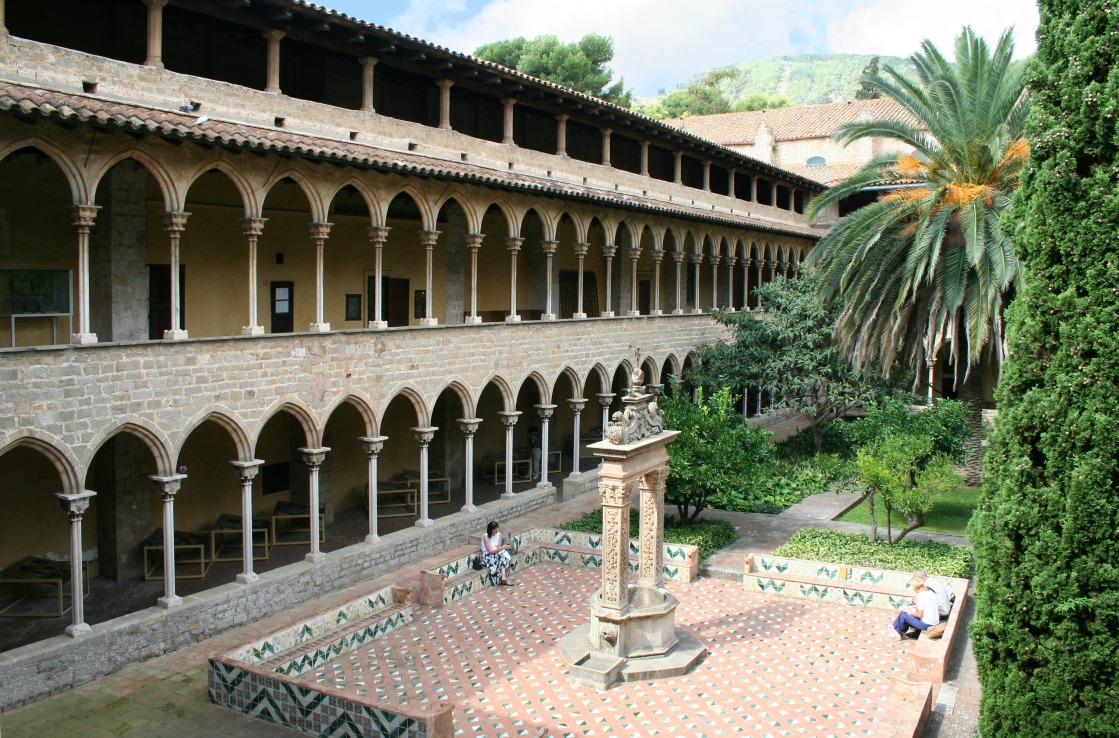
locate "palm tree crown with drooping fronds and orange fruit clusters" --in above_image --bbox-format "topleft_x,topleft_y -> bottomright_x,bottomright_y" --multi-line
808,27 -> 1028,384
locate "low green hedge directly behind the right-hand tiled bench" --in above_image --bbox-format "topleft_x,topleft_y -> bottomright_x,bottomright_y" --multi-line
773,528 -> 974,578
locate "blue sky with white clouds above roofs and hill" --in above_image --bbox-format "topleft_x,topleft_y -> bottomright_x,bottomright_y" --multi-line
316,0 -> 1037,96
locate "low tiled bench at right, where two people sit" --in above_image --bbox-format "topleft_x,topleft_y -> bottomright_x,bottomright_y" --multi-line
742,554 -> 968,682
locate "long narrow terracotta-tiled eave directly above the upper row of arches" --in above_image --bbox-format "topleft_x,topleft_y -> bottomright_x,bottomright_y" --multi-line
0,82 -> 819,239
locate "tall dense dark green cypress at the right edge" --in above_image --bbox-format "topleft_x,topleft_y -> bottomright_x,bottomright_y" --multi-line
969,0 -> 1119,738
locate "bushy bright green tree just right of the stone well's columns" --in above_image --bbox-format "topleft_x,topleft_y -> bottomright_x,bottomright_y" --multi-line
660,382 -> 773,524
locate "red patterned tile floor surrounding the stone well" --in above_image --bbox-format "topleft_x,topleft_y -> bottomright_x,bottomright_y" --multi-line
286,564 -> 916,737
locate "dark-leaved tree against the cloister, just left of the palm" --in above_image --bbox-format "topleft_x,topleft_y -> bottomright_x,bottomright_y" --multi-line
694,271 -> 880,453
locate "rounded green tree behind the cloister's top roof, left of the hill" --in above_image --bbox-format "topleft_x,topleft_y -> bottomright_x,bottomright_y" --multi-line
474,34 -> 633,107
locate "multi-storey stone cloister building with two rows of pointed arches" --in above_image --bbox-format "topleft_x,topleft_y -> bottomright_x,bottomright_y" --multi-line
0,0 -> 822,707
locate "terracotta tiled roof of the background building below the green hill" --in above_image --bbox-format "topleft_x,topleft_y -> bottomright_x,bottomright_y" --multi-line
665,97 -> 916,146
